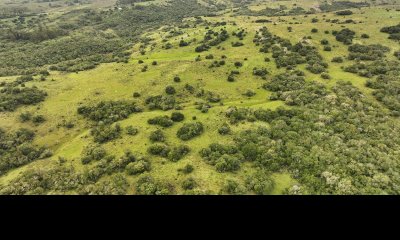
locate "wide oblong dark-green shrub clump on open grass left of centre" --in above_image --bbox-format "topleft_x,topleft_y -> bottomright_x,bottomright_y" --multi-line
78,101 -> 142,124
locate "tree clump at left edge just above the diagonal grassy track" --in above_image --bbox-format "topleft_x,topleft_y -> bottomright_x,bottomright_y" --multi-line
0,128 -> 52,175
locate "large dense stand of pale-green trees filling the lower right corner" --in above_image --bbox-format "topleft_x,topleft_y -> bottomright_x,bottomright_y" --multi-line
225,82 -> 400,194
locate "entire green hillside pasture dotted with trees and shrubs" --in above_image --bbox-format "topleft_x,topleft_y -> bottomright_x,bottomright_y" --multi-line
0,0 -> 400,195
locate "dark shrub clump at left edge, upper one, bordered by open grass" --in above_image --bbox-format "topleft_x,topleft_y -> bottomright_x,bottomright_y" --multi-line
0,87 -> 47,112
